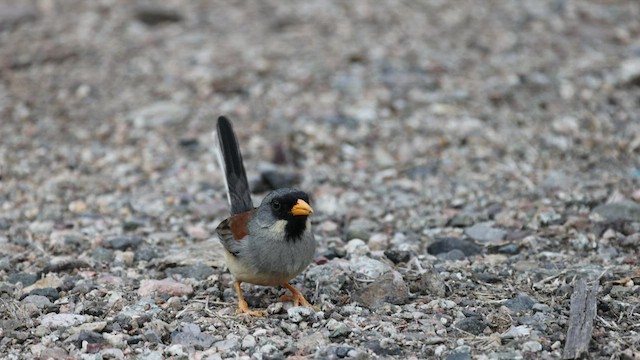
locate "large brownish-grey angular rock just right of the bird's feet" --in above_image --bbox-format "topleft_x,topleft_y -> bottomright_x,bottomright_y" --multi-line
355,271 -> 409,309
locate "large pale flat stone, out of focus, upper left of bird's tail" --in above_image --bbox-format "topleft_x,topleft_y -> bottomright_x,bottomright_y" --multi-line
129,102 -> 189,128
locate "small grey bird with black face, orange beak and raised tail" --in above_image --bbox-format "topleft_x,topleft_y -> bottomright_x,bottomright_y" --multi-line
216,116 -> 316,316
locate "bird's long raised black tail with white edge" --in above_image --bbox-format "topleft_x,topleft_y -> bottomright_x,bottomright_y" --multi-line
217,116 -> 253,215
